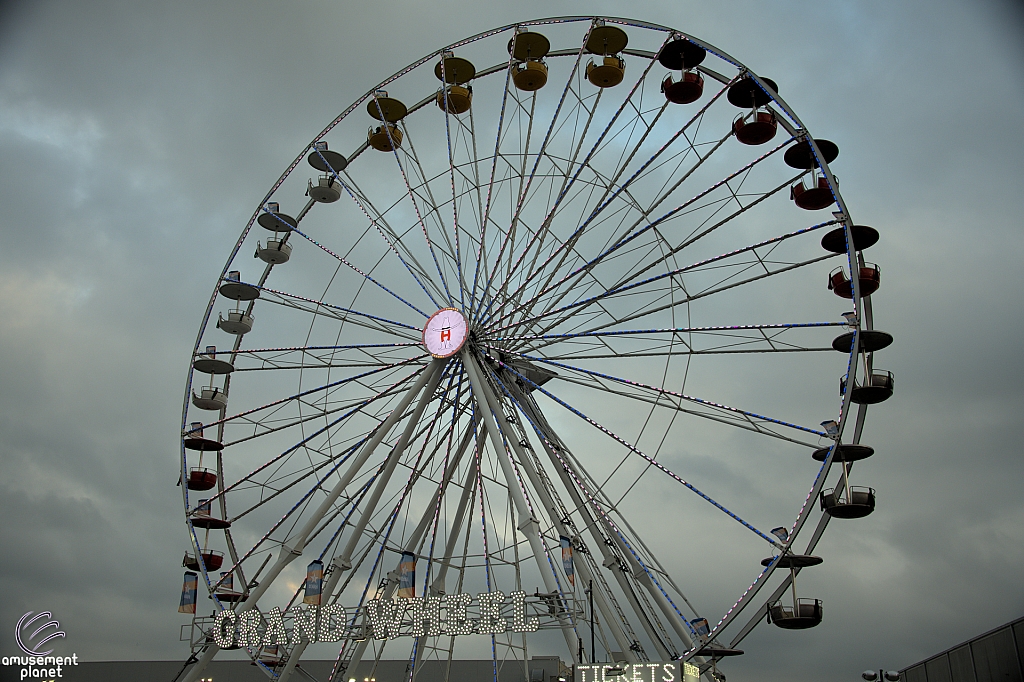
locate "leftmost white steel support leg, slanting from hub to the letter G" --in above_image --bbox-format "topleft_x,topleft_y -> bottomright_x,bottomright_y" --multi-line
182,359 -> 444,682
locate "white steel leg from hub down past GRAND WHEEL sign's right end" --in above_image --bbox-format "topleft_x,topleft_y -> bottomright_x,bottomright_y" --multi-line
463,350 -> 580,664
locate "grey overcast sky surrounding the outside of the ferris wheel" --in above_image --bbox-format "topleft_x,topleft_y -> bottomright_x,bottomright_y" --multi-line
0,0 -> 1024,682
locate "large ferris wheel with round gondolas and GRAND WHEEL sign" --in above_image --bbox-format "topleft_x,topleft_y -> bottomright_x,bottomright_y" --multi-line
179,17 -> 893,681
